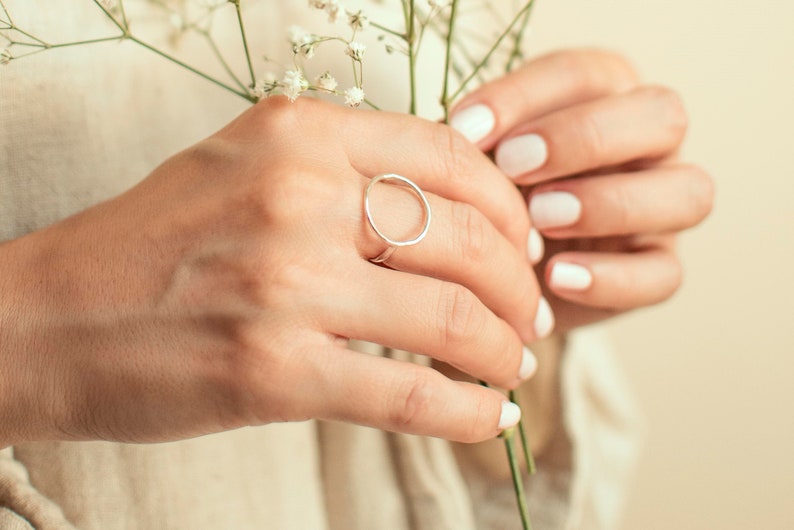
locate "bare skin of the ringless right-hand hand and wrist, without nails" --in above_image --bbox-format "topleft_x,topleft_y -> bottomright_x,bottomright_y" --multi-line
453,49 -> 714,476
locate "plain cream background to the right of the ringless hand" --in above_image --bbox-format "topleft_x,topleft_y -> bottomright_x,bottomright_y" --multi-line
531,0 -> 794,530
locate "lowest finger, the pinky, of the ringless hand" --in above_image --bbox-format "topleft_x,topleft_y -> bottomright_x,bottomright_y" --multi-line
546,248 -> 682,311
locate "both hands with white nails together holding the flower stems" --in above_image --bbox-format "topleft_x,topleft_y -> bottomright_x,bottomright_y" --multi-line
0,50 -> 713,446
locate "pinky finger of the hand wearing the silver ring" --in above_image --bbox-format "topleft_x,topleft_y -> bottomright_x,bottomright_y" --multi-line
310,348 -> 521,442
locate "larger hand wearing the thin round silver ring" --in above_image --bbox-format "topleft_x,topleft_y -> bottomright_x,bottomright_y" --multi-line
0,98 -> 548,447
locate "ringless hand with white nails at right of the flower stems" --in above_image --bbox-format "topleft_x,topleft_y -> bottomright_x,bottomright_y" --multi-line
451,50 -> 714,331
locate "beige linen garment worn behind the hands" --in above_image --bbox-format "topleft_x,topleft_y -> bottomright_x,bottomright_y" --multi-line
0,0 -> 636,530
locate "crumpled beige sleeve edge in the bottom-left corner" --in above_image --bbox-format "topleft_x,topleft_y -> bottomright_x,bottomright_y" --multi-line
0,447 -> 76,530
